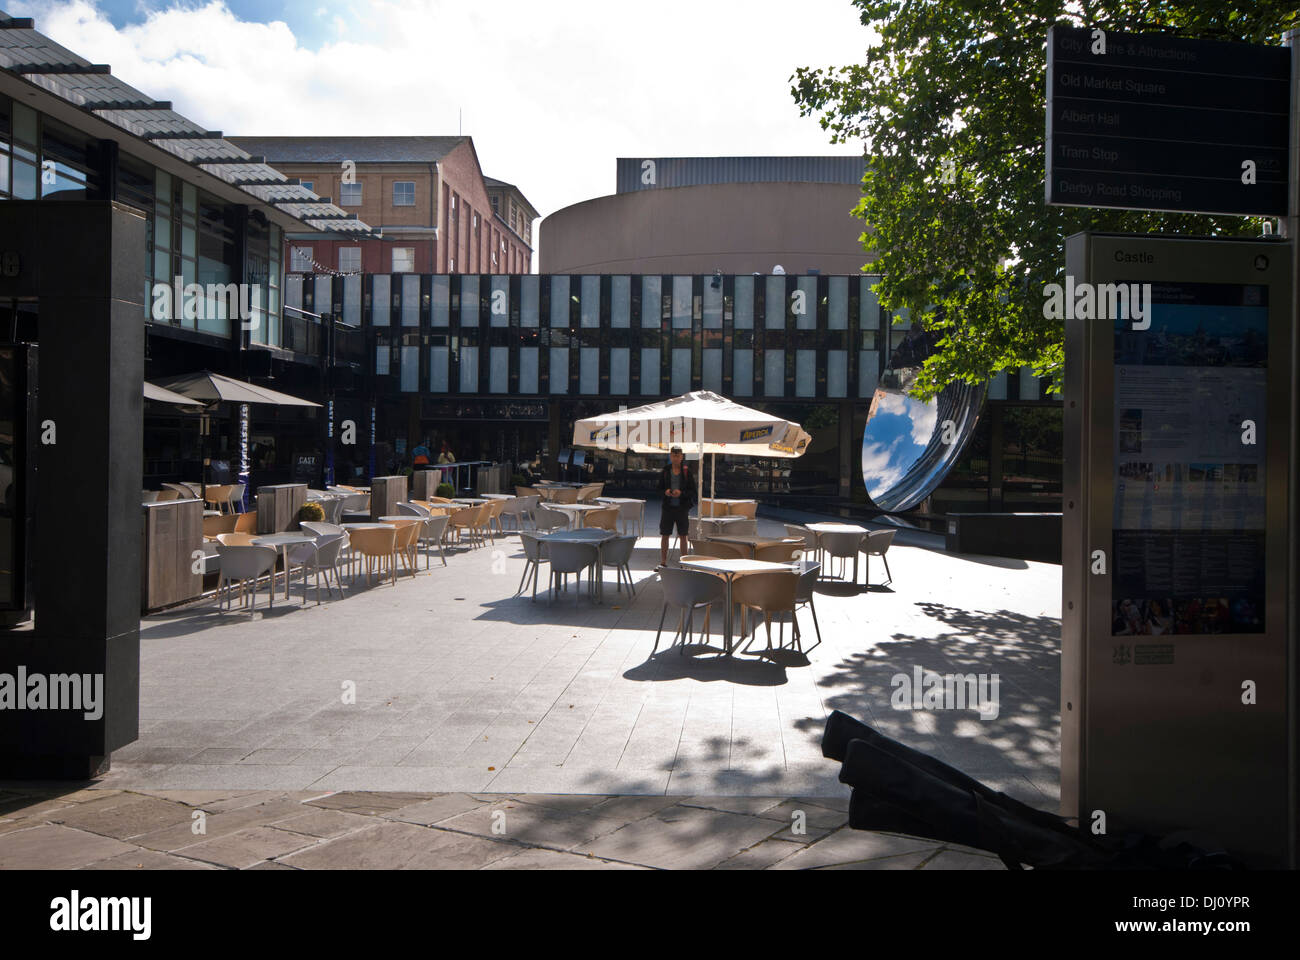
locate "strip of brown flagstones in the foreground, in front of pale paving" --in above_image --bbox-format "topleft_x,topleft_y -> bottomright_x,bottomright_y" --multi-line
0,788 -> 1004,870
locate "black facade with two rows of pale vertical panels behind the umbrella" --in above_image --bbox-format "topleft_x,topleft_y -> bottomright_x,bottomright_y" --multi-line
286,273 -> 1060,509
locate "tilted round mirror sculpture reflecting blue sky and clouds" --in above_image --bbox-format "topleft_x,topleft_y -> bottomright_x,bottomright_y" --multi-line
862,368 -> 984,511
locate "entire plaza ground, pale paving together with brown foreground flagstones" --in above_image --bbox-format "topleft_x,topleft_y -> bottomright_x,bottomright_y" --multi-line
0,486 -> 1060,869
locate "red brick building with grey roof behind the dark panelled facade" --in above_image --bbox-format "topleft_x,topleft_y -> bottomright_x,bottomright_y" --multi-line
229,137 -> 537,273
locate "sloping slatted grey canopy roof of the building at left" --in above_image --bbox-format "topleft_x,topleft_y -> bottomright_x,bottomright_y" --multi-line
0,14 -> 378,235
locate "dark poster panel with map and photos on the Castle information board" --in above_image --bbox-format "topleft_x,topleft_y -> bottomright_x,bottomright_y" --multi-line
1112,282 -> 1269,636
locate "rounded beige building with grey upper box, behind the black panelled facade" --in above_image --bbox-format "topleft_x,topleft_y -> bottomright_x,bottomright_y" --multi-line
540,156 -> 868,274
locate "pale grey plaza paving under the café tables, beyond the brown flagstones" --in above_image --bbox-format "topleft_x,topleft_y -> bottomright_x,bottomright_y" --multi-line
0,505 -> 1061,810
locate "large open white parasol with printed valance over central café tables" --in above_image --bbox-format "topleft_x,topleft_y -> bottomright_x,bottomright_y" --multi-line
573,390 -> 813,514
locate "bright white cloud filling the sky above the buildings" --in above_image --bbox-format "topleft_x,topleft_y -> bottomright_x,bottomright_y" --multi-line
13,0 -> 870,254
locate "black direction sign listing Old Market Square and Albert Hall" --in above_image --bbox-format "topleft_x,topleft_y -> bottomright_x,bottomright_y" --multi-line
1047,27 -> 1291,216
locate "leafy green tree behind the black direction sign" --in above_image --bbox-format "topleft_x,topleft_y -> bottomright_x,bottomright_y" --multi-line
790,0 -> 1300,398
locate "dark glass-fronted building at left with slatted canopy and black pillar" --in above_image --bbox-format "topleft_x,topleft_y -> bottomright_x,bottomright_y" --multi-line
0,13 -> 371,778
